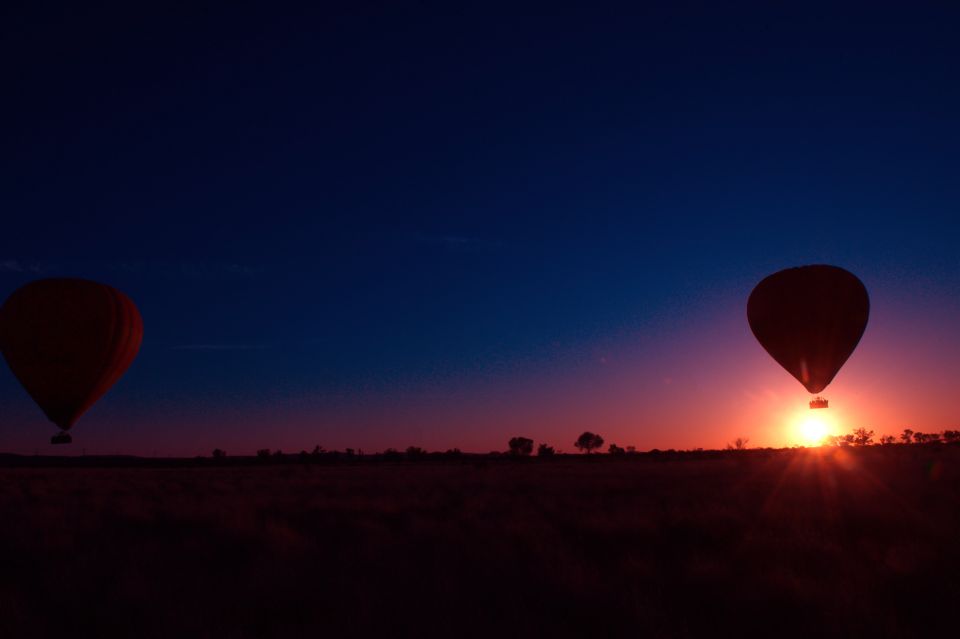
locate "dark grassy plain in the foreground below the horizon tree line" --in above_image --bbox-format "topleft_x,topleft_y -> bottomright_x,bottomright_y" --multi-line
0,446 -> 960,638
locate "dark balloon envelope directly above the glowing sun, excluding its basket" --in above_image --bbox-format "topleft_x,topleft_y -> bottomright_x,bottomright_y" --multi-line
747,265 -> 870,393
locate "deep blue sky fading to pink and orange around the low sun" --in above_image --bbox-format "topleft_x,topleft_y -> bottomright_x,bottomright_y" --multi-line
0,1 -> 960,455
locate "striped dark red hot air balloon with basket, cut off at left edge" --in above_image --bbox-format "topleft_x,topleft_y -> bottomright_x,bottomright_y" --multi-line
0,278 -> 143,444
